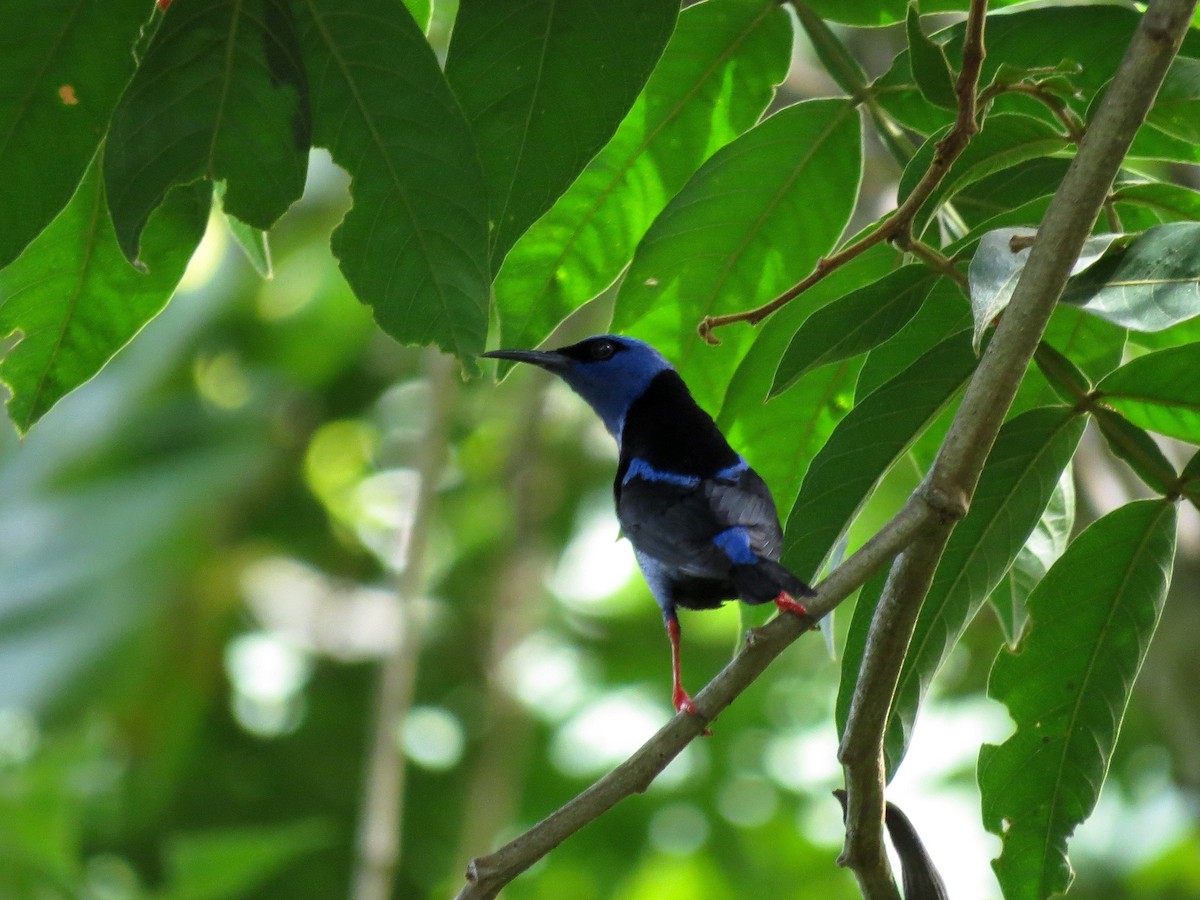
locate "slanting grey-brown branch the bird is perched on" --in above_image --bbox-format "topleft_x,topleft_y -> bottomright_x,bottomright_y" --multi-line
458,497 -> 941,900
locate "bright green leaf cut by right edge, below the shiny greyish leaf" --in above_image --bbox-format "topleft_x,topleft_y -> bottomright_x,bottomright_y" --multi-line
1096,343 -> 1200,444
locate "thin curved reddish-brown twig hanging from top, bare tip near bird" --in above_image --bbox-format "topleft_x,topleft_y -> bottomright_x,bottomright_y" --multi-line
696,0 -> 988,344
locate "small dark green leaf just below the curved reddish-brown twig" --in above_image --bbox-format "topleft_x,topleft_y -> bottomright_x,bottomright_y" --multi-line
770,265 -> 938,397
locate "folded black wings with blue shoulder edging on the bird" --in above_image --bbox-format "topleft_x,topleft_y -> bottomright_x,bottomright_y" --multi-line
616,460 -> 782,577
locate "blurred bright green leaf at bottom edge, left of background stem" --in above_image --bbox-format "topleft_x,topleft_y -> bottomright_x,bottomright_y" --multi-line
166,821 -> 332,900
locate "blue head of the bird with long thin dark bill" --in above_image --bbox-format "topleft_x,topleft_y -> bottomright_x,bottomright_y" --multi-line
484,335 -> 671,442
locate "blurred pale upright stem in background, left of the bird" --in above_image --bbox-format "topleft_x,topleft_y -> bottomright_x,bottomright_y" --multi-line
354,350 -> 456,900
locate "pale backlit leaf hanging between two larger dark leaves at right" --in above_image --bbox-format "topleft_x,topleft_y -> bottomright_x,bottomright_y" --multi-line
988,464 -> 1075,647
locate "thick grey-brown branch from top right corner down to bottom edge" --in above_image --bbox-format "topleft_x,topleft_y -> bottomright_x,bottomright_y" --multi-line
840,0 -> 1195,898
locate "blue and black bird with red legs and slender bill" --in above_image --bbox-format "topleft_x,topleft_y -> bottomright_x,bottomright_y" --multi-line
482,334 -> 815,715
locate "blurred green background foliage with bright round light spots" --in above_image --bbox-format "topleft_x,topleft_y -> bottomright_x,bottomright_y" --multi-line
0,4 -> 1200,900
